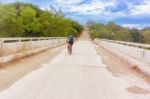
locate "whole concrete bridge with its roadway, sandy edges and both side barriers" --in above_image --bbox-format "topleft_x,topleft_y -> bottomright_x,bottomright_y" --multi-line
0,31 -> 150,99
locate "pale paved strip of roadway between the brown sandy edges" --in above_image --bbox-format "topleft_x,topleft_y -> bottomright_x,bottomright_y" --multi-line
0,41 -> 150,99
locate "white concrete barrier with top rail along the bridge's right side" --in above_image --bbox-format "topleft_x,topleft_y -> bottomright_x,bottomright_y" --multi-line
95,39 -> 150,64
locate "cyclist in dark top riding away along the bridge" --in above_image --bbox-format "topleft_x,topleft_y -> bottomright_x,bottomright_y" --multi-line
67,34 -> 74,54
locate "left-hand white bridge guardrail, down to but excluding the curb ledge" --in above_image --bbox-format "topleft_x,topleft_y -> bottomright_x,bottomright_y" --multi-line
0,37 -> 66,57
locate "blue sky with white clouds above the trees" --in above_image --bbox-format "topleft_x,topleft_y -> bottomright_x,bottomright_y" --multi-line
0,0 -> 150,28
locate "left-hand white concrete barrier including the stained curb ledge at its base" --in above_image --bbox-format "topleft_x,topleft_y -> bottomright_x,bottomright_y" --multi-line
0,37 -> 66,64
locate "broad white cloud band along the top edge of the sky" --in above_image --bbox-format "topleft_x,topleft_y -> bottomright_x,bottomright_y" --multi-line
54,0 -> 150,18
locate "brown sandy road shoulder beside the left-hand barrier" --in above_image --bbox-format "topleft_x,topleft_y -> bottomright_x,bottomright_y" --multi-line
0,45 -> 66,91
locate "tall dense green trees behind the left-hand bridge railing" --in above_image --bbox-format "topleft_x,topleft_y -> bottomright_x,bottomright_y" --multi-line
0,2 -> 83,37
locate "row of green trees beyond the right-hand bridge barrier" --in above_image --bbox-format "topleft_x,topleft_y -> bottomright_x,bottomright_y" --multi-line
88,21 -> 150,44
